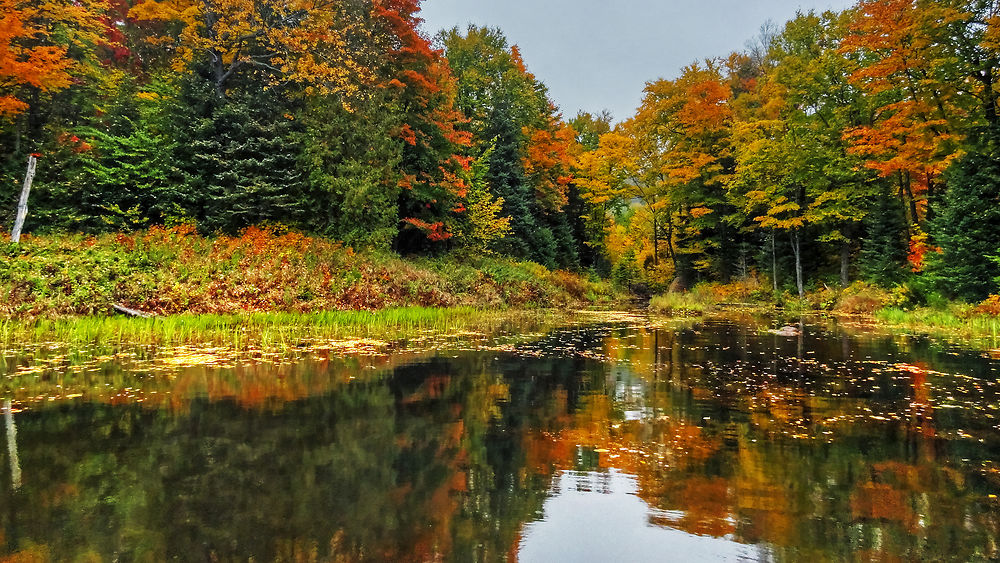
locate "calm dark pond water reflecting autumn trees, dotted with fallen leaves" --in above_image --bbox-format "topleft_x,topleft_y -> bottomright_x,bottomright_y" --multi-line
0,321 -> 1000,562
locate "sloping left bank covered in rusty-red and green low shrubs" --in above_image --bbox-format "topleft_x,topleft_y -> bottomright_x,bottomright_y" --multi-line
0,227 -> 618,322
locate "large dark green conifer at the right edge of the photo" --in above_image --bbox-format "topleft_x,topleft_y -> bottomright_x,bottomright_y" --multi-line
931,132 -> 1000,301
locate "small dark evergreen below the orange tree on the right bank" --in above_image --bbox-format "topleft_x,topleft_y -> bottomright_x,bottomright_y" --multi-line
858,189 -> 907,287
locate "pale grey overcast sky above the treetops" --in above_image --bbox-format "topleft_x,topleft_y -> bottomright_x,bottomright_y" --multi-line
421,0 -> 854,121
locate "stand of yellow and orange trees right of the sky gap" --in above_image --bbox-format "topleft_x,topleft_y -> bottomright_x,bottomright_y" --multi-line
580,0 -> 1000,301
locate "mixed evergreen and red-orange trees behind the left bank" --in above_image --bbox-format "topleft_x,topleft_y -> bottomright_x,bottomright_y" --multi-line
0,0 -> 588,268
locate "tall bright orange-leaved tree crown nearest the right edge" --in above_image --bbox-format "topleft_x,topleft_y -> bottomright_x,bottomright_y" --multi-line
841,0 -> 980,225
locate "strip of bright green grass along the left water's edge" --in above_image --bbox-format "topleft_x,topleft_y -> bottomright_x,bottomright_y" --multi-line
0,307 -> 554,350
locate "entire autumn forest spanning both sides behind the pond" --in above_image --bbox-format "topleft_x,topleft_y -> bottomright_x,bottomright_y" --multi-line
0,0 -> 1000,312
